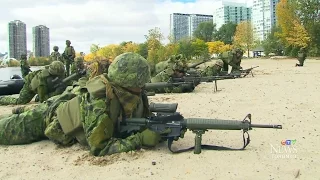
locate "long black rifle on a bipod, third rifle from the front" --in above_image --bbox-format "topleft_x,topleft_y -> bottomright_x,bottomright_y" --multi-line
169,75 -> 236,92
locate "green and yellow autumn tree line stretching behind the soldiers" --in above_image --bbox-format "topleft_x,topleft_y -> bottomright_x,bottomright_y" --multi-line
85,0 -> 320,64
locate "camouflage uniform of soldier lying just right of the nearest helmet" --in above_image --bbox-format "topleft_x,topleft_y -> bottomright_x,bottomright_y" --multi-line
151,61 -> 194,93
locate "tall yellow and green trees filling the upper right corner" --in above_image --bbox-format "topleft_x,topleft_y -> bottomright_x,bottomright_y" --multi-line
263,0 -> 320,56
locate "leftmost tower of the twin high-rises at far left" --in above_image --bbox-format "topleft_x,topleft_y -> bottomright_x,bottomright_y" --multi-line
8,20 -> 27,59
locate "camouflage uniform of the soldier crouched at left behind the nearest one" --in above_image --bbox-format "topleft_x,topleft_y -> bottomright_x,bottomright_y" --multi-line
0,61 -> 65,105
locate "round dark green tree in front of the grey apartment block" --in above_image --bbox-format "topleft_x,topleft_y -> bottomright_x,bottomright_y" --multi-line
193,21 -> 216,42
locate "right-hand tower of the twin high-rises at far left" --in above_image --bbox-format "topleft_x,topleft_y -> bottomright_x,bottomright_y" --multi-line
32,25 -> 50,57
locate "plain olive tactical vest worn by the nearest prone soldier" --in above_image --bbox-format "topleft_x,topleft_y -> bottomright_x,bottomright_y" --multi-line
56,75 -> 148,145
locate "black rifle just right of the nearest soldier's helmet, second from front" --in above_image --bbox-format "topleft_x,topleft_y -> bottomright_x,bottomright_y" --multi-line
144,82 -> 195,96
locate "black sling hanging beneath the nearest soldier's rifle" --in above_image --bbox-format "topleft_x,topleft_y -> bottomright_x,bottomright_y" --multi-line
168,131 -> 250,153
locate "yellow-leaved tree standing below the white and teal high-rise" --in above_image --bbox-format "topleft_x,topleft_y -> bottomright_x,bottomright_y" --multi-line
233,21 -> 256,57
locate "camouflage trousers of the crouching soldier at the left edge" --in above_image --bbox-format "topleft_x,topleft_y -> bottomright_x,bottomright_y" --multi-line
0,73 -> 36,105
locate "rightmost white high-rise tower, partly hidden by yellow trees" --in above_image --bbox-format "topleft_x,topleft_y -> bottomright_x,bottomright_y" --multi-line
252,0 -> 279,41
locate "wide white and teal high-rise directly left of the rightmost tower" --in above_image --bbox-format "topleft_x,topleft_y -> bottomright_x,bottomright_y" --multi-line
213,1 -> 252,29
